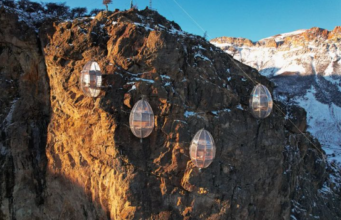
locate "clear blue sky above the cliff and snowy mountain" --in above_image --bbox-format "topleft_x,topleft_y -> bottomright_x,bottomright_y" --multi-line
37,0 -> 341,41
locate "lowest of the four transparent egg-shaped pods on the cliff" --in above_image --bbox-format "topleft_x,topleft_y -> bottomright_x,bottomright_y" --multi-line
189,129 -> 216,168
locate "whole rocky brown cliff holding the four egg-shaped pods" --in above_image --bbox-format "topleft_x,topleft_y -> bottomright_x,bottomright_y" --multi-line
0,4 -> 341,219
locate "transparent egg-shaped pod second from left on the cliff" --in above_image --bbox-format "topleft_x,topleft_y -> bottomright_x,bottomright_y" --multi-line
129,99 -> 154,138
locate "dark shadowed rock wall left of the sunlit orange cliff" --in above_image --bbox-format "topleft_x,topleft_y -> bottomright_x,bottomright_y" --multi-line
0,8 -> 51,219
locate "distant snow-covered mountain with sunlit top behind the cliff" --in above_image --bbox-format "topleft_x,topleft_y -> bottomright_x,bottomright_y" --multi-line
211,26 -> 341,163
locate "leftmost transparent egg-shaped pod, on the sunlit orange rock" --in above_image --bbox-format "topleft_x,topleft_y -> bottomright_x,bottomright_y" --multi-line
80,61 -> 102,97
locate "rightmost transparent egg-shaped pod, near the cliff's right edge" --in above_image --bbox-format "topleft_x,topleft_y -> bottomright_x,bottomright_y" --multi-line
249,84 -> 273,118
